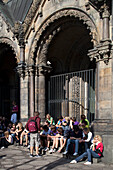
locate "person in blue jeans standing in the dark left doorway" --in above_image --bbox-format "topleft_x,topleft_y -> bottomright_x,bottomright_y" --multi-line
11,101 -> 18,124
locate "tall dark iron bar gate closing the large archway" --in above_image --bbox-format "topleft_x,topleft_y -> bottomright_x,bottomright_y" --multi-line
48,70 -> 95,122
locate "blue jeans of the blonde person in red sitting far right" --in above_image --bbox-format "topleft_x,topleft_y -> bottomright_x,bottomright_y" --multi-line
75,149 -> 100,162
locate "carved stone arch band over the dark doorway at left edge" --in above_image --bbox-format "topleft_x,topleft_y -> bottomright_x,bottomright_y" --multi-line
0,37 -> 19,63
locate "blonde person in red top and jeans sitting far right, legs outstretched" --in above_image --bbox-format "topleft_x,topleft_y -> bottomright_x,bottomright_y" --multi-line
70,135 -> 103,165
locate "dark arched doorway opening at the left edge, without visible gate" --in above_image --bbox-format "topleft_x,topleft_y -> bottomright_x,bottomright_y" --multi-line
0,43 -> 19,119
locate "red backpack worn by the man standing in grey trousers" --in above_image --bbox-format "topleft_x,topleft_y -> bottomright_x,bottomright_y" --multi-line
28,118 -> 38,133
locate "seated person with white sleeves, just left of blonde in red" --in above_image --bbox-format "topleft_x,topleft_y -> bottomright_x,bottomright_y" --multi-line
79,128 -> 93,152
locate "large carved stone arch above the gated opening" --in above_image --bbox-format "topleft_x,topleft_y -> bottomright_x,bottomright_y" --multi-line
28,8 -> 99,63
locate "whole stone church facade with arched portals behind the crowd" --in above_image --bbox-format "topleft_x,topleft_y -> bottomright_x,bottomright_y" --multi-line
0,0 -> 113,163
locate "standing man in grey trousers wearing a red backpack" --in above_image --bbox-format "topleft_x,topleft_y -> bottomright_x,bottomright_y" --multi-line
26,112 -> 41,158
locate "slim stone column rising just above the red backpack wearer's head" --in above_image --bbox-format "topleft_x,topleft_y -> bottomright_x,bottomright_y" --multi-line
29,66 -> 35,117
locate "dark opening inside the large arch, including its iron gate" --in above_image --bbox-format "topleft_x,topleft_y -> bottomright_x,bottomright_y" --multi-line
46,17 -> 95,121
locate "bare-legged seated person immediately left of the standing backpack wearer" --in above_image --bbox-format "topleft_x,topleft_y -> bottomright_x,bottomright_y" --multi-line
20,128 -> 30,147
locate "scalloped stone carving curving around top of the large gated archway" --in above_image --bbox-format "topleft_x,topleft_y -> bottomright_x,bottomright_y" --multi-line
29,9 -> 98,63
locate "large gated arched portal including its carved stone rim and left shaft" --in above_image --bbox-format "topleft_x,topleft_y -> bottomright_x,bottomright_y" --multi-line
29,9 -> 98,120
